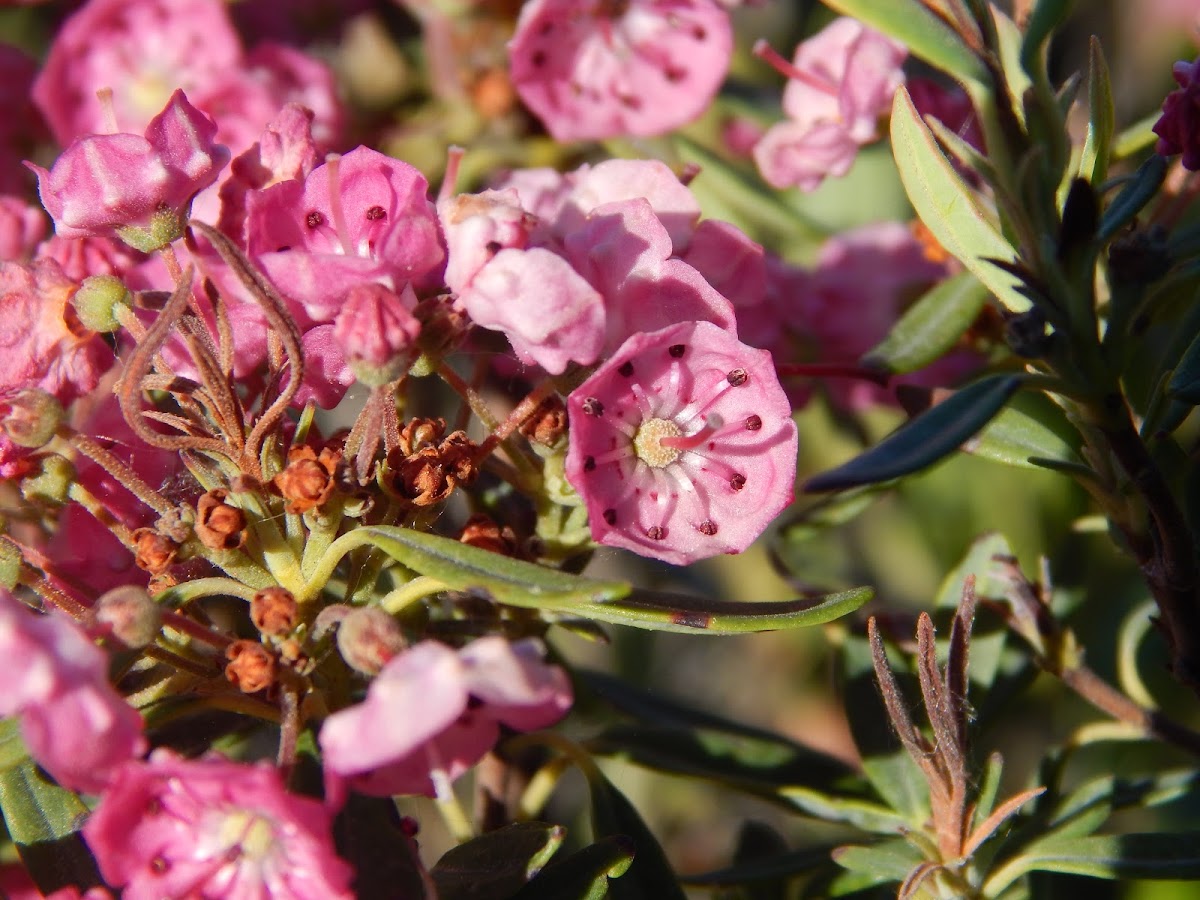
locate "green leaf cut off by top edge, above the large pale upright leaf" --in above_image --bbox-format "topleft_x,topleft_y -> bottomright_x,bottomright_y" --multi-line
824,0 -> 988,84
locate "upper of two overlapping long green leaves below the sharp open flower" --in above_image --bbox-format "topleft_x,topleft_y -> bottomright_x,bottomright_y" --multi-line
358,526 -> 630,606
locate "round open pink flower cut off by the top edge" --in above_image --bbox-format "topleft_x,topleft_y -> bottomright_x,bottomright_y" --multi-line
509,0 -> 733,140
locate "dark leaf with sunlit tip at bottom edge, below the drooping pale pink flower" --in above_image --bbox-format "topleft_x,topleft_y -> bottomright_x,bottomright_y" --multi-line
430,822 -> 566,900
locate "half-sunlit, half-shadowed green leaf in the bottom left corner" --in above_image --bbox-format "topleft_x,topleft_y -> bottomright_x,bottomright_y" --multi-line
0,761 -> 103,894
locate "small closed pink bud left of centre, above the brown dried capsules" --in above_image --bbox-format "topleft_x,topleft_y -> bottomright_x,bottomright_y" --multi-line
334,283 -> 421,388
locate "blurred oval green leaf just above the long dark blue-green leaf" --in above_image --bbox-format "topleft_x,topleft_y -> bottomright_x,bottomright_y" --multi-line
862,272 -> 991,374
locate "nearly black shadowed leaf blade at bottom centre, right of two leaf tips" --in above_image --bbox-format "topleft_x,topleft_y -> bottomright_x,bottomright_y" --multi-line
584,769 -> 685,900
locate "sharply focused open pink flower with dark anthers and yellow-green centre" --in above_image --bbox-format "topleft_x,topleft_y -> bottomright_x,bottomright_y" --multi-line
566,322 -> 797,565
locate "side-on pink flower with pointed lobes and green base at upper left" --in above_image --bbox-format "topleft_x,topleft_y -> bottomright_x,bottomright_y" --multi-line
26,91 -> 229,251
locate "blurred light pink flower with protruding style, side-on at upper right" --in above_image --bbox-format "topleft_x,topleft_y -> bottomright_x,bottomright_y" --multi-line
754,18 -> 907,191
